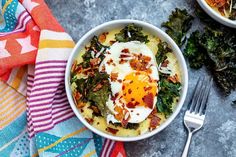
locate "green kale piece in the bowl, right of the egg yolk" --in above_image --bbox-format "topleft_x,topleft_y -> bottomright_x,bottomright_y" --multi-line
156,75 -> 181,117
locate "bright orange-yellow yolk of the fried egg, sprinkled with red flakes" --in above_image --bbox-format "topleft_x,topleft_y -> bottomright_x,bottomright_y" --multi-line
122,71 -> 157,109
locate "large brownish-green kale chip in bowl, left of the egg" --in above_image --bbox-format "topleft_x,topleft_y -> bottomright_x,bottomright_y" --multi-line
75,71 -> 111,116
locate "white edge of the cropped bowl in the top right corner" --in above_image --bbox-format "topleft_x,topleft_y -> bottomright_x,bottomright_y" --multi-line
197,0 -> 236,28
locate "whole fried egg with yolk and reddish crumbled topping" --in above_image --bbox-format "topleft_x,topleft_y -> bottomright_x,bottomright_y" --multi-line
99,41 -> 159,125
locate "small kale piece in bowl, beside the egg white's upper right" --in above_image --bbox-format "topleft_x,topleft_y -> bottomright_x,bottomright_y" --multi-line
155,42 -> 172,65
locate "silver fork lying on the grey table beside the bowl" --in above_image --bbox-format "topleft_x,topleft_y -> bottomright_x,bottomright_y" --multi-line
182,77 -> 213,157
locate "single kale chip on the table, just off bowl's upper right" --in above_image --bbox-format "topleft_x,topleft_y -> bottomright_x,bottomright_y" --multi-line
162,8 -> 193,46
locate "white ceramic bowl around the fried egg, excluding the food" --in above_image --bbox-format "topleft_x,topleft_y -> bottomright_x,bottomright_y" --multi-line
65,19 -> 188,141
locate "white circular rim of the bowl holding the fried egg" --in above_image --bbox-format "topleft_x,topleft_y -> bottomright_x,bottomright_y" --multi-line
65,19 -> 188,142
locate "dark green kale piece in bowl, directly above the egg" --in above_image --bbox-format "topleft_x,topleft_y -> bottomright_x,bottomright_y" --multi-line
115,24 -> 149,43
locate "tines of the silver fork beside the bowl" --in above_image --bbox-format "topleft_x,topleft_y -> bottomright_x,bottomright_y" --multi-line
188,77 -> 213,115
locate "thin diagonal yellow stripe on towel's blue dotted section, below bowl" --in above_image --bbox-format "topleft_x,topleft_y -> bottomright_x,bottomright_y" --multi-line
38,127 -> 87,153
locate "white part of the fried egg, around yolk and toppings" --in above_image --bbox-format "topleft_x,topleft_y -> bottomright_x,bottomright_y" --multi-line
99,41 -> 159,123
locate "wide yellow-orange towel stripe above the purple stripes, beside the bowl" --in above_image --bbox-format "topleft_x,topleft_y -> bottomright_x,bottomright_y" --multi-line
39,39 -> 75,49
